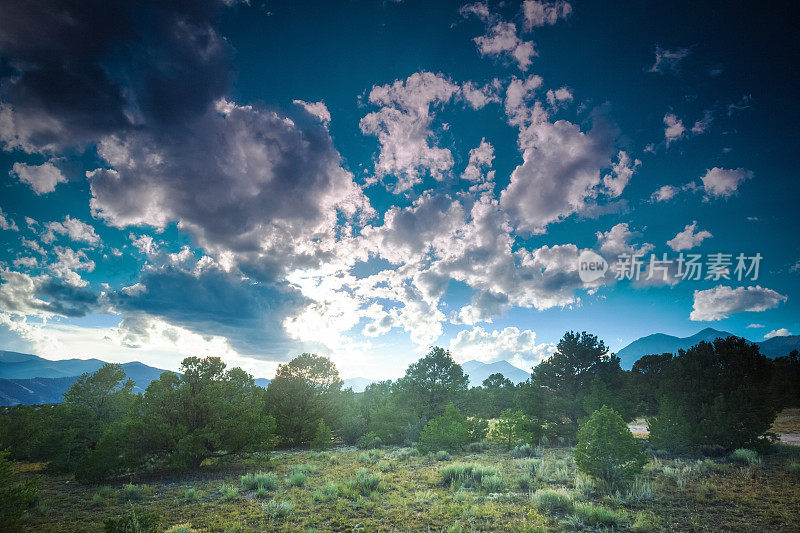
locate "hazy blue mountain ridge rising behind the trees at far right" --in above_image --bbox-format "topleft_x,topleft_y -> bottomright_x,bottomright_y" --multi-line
617,328 -> 800,370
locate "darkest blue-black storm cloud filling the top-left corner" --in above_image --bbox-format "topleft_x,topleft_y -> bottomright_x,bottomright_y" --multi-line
0,0 -> 230,152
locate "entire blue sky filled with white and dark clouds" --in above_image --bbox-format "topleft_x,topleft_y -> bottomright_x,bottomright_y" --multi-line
0,0 -> 800,379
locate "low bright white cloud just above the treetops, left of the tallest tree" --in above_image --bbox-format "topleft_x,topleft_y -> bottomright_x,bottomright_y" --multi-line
450,326 -> 555,368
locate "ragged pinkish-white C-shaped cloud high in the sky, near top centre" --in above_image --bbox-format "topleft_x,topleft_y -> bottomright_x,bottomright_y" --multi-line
360,72 -> 459,193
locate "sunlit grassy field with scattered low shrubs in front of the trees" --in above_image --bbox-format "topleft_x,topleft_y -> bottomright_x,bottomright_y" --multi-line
19,438 -> 800,532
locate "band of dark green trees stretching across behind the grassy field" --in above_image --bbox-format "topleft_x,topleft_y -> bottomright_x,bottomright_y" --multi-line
0,331 -> 800,482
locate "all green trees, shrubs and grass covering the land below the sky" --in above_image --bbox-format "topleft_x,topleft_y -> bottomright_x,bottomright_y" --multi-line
0,332 -> 800,532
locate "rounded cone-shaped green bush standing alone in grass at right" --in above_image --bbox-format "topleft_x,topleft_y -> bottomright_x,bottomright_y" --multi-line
574,405 -> 647,487
